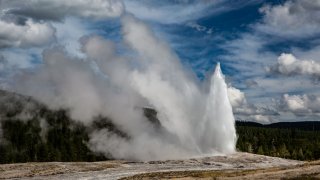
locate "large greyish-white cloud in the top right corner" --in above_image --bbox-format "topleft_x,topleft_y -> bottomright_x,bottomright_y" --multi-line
255,0 -> 320,38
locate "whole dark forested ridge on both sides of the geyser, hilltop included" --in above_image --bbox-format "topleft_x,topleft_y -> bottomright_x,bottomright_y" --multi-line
0,90 -> 320,163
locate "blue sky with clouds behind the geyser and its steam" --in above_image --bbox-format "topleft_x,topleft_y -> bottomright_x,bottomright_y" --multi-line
0,0 -> 320,123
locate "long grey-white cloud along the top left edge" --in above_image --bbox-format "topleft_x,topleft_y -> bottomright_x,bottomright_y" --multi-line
0,0 -> 124,21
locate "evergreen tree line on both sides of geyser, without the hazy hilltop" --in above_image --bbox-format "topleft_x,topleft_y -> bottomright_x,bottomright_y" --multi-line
0,115 -> 320,163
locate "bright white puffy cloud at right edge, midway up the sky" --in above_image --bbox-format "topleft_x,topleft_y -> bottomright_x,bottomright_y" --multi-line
267,53 -> 320,79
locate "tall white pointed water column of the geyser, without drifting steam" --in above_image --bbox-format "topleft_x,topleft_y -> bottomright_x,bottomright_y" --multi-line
199,63 -> 237,154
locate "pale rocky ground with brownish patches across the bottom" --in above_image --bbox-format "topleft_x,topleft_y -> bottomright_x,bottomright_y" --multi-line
0,152 -> 320,179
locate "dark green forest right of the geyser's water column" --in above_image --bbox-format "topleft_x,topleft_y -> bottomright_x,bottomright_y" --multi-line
236,122 -> 320,160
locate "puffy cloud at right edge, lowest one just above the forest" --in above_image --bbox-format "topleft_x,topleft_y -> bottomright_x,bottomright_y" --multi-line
280,94 -> 320,116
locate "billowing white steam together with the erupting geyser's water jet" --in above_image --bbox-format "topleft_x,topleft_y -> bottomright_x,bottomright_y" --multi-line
17,15 -> 236,160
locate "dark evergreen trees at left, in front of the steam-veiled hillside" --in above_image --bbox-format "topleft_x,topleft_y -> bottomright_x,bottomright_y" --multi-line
0,110 -> 108,163
